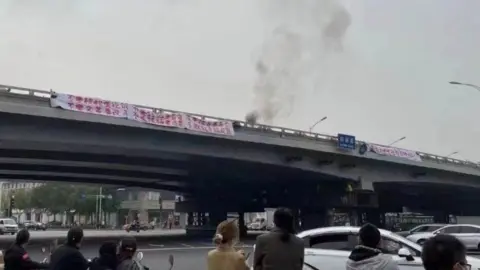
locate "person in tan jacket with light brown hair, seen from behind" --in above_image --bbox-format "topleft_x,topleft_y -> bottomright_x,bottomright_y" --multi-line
207,220 -> 249,270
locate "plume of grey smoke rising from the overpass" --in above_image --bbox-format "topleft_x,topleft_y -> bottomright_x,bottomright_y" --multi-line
251,0 -> 351,124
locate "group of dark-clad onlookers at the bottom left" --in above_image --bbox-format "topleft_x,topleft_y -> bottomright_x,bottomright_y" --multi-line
3,227 -> 145,270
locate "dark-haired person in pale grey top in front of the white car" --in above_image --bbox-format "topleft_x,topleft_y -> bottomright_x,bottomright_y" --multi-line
347,223 -> 399,270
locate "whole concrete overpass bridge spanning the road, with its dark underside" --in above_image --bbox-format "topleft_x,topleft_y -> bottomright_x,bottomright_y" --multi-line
0,86 -> 480,230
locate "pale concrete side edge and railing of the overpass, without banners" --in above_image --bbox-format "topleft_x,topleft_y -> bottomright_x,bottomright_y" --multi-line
0,85 -> 480,176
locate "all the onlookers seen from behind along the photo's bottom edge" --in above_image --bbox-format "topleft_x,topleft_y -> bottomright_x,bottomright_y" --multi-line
0,208 -> 471,270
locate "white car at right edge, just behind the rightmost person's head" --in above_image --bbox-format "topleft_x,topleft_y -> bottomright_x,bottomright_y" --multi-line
407,224 -> 480,249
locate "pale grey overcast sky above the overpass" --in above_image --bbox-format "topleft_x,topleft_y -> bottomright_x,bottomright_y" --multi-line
0,0 -> 480,161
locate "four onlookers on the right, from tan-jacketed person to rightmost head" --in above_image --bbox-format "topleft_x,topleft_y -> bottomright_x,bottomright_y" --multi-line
207,208 -> 471,270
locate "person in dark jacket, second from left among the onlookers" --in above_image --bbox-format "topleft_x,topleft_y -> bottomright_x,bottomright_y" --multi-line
49,227 -> 89,270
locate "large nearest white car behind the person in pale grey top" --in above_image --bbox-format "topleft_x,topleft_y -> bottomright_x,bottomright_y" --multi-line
254,226 -> 480,270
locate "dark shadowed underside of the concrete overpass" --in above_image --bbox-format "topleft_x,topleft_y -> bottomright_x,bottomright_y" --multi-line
0,113 -> 480,230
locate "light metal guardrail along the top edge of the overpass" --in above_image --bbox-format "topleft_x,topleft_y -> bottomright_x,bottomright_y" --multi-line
0,85 -> 480,168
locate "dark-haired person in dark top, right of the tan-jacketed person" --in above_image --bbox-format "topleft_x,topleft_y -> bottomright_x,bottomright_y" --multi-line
253,208 -> 305,270
